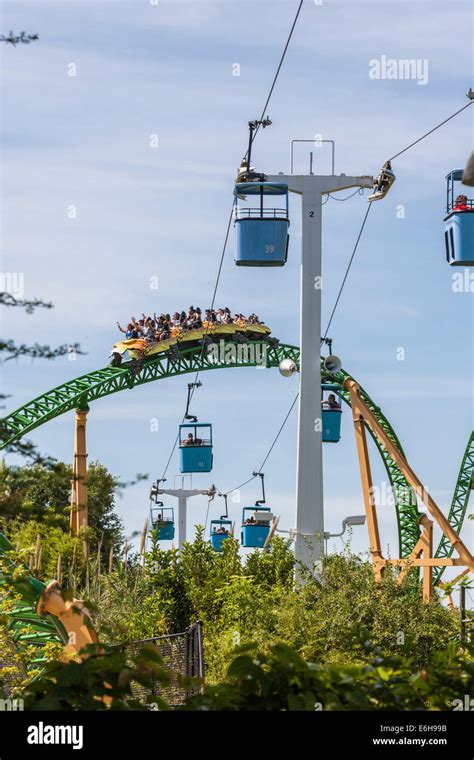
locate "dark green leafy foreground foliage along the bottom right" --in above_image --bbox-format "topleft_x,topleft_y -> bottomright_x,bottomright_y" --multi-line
184,642 -> 474,712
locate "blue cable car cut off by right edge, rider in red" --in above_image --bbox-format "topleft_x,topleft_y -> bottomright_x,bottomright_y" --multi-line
444,169 -> 474,266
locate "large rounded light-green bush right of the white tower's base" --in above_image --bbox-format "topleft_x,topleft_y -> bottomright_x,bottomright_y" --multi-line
276,553 -> 457,666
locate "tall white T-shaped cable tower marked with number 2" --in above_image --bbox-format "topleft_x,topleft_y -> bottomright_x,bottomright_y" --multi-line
266,174 -> 374,569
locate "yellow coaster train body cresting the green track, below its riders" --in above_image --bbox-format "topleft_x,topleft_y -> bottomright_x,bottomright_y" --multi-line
110,321 -> 271,365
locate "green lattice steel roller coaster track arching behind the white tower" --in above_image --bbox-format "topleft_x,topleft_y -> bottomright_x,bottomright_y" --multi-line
0,341 -> 474,664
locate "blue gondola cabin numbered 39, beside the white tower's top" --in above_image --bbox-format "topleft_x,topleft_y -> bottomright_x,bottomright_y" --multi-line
234,182 -> 290,267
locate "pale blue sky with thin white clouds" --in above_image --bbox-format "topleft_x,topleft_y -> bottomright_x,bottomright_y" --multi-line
0,0 -> 474,580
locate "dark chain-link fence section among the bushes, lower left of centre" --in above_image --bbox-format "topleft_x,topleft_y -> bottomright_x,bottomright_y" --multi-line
125,622 -> 204,707
